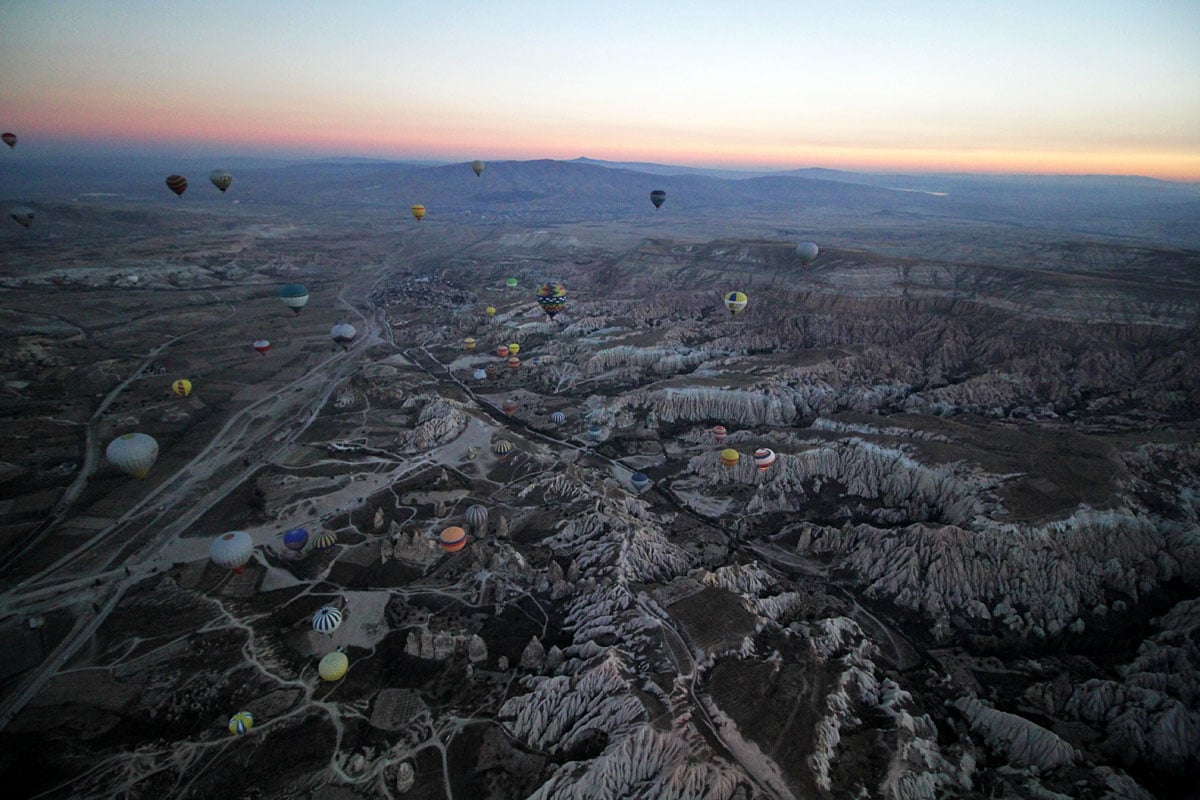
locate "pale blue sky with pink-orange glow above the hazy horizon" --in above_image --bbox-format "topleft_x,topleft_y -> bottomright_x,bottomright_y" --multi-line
0,0 -> 1200,180
